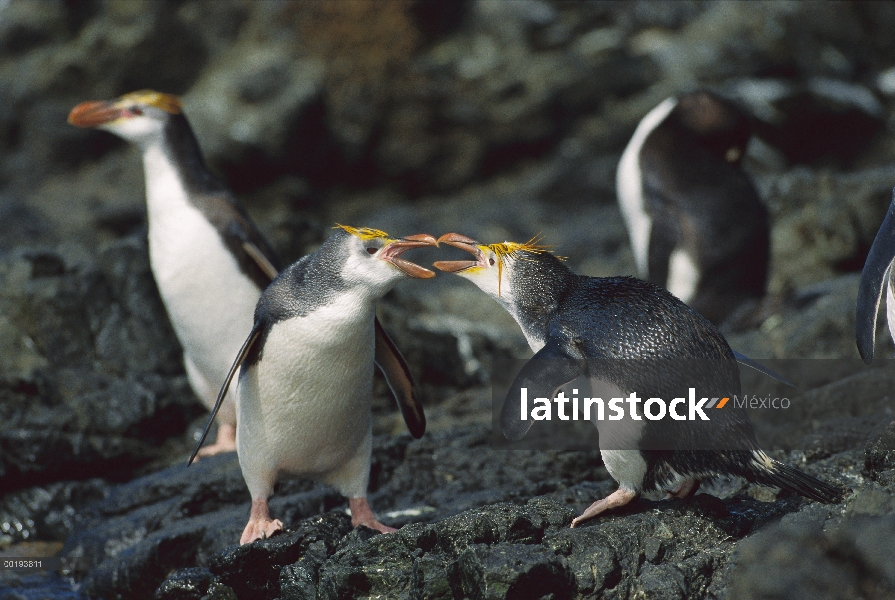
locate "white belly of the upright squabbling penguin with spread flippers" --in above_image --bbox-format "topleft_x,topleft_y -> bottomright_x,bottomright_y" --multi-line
237,294 -> 375,493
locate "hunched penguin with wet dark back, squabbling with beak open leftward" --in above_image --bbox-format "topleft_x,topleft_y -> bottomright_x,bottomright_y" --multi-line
435,233 -> 842,527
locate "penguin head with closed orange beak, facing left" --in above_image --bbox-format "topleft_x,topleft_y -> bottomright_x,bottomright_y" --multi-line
68,90 -> 182,146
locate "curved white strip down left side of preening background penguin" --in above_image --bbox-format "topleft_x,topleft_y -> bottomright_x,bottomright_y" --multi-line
615,98 -> 677,277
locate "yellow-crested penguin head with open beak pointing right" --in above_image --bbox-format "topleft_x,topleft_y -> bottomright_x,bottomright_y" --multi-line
335,225 -> 438,289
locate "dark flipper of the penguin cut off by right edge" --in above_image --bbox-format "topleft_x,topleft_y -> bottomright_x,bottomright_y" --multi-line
855,190 -> 895,364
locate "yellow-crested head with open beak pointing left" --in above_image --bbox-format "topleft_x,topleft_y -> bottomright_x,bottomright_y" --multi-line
435,233 -> 568,305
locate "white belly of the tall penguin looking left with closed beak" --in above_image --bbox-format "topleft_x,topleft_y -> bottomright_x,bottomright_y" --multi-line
141,148 -> 261,414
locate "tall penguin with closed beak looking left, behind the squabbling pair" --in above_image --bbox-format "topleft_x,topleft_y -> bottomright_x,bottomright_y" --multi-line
68,90 -> 279,456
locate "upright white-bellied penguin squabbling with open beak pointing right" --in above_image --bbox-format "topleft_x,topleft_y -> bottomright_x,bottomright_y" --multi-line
190,225 -> 436,544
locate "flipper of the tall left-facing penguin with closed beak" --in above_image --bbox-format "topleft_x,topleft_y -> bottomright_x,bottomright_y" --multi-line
196,193 -> 280,290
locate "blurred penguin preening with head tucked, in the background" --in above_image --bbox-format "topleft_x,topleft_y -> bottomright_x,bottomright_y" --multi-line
616,91 -> 770,324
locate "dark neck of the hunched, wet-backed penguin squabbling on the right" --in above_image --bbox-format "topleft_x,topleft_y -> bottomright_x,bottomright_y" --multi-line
501,254 -> 580,351
